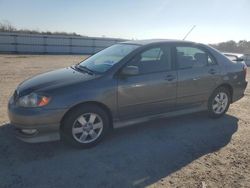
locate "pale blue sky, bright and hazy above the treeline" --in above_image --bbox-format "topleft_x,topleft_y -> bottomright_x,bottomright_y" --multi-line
0,0 -> 250,43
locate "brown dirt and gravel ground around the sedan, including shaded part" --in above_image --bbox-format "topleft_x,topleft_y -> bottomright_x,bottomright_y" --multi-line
0,55 -> 250,188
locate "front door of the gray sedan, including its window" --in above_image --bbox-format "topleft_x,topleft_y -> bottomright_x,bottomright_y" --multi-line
118,45 -> 177,119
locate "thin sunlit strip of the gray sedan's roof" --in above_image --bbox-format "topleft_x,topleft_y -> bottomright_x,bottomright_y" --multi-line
122,39 -> 195,46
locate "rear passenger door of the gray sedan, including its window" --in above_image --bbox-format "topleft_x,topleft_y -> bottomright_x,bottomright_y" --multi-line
176,45 -> 220,107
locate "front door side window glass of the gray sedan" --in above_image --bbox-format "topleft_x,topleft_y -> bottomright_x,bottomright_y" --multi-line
129,47 -> 171,74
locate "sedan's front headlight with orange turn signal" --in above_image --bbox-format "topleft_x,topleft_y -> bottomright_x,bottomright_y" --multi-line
17,93 -> 51,107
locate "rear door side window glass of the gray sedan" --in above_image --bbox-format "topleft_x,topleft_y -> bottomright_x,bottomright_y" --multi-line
176,46 -> 216,69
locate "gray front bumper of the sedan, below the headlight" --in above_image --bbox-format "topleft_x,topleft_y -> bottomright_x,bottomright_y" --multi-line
8,103 -> 67,143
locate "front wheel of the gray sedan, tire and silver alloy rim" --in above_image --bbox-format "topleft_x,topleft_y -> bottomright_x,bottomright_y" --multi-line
61,105 -> 110,148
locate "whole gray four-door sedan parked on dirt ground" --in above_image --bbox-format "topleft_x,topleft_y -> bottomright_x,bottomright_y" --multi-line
8,40 -> 247,148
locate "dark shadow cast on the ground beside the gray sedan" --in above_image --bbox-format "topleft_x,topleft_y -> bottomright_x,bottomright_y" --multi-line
0,113 -> 238,188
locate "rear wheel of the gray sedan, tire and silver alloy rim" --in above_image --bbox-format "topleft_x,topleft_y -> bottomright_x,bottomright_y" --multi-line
208,87 -> 231,118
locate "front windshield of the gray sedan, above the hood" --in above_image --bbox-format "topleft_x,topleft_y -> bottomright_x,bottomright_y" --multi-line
79,44 -> 139,73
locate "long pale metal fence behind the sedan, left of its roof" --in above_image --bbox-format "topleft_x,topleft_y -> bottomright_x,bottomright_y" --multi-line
0,32 -> 124,54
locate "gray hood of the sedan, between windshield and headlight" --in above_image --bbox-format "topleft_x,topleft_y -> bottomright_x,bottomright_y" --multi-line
17,67 -> 97,96
